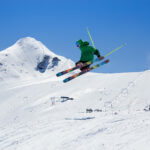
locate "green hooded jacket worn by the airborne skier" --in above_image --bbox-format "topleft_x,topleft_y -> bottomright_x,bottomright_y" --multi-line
77,40 -> 100,61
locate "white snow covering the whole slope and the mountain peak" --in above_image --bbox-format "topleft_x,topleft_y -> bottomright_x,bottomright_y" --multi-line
0,37 -> 150,150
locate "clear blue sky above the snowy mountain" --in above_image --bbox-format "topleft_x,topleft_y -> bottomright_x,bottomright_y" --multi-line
0,0 -> 150,73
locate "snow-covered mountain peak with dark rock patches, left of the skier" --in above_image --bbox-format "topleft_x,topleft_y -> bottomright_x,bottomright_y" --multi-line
0,37 -> 73,81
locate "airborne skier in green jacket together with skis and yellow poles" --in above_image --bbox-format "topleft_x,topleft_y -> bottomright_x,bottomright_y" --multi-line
56,36 -> 125,83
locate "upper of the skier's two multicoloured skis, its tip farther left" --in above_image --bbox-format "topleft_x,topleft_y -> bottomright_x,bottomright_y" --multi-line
56,57 -> 104,77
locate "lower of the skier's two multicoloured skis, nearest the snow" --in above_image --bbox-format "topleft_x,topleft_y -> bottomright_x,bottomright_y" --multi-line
63,59 -> 109,83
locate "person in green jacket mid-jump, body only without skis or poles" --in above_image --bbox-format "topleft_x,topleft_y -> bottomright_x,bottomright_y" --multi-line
76,39 -> 104,71
